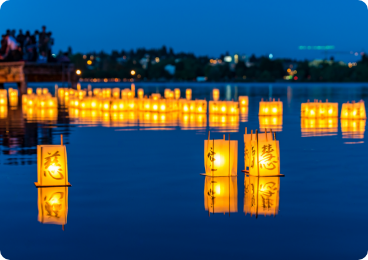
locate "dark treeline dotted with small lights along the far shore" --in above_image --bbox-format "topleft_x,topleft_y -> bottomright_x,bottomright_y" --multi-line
70,46 -> 368,82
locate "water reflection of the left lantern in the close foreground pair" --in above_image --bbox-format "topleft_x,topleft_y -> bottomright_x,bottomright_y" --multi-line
204,176 -> 238,214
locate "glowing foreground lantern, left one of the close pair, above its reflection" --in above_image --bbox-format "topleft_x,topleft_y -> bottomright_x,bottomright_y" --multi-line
204,132 -> 238,176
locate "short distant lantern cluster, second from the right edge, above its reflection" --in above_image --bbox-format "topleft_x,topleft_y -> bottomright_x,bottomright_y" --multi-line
301,100 -> 339,118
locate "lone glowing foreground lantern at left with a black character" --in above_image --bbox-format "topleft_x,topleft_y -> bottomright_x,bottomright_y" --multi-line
35,136 -> 71,187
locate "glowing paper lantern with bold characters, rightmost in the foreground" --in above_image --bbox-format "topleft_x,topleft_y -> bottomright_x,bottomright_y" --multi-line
244,130 -> 283,177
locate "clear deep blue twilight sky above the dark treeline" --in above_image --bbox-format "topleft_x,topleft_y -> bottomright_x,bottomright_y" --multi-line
0,0 -> 368,61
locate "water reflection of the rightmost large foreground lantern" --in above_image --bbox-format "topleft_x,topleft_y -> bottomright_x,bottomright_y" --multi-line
244,176 -> 280,218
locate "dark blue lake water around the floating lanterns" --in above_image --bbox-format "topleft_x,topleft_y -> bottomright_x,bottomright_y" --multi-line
0,84 -> 368,260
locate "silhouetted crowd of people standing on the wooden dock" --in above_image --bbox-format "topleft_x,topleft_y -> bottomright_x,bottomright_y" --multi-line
0,26 -> 69,63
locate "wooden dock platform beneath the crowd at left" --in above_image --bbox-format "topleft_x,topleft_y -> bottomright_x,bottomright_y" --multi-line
0,61 -> 79,94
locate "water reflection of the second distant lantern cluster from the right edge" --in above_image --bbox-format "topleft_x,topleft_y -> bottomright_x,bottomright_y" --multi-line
301,117 -> 338,137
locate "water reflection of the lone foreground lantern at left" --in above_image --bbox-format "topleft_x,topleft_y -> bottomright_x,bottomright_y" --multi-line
38,187 -> 68,226
